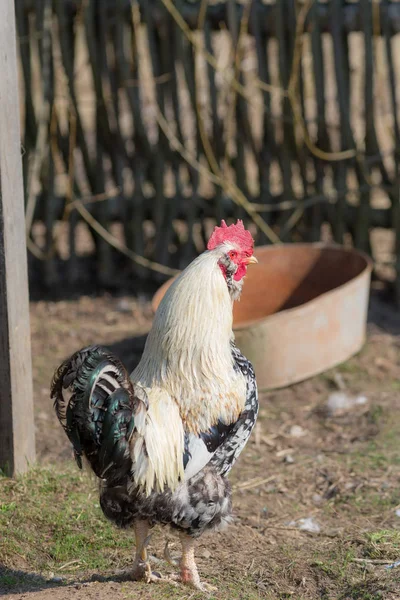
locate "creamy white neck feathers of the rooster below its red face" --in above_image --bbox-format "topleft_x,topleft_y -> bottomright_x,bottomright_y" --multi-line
132,244 -> 245,428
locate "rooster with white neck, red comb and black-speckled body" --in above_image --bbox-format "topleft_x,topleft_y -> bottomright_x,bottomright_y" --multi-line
51,221 -> 258,590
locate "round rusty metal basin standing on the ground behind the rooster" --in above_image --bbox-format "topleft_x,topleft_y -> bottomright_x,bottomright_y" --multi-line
153,244 -> 372,389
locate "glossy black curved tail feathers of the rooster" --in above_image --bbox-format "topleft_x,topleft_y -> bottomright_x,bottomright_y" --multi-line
51,346 -> 136,483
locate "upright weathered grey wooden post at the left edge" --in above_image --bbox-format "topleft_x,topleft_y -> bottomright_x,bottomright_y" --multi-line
0,0 -> 35,475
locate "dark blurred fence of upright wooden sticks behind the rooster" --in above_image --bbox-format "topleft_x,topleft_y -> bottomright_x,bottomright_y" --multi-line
16,0 -> 400,297
